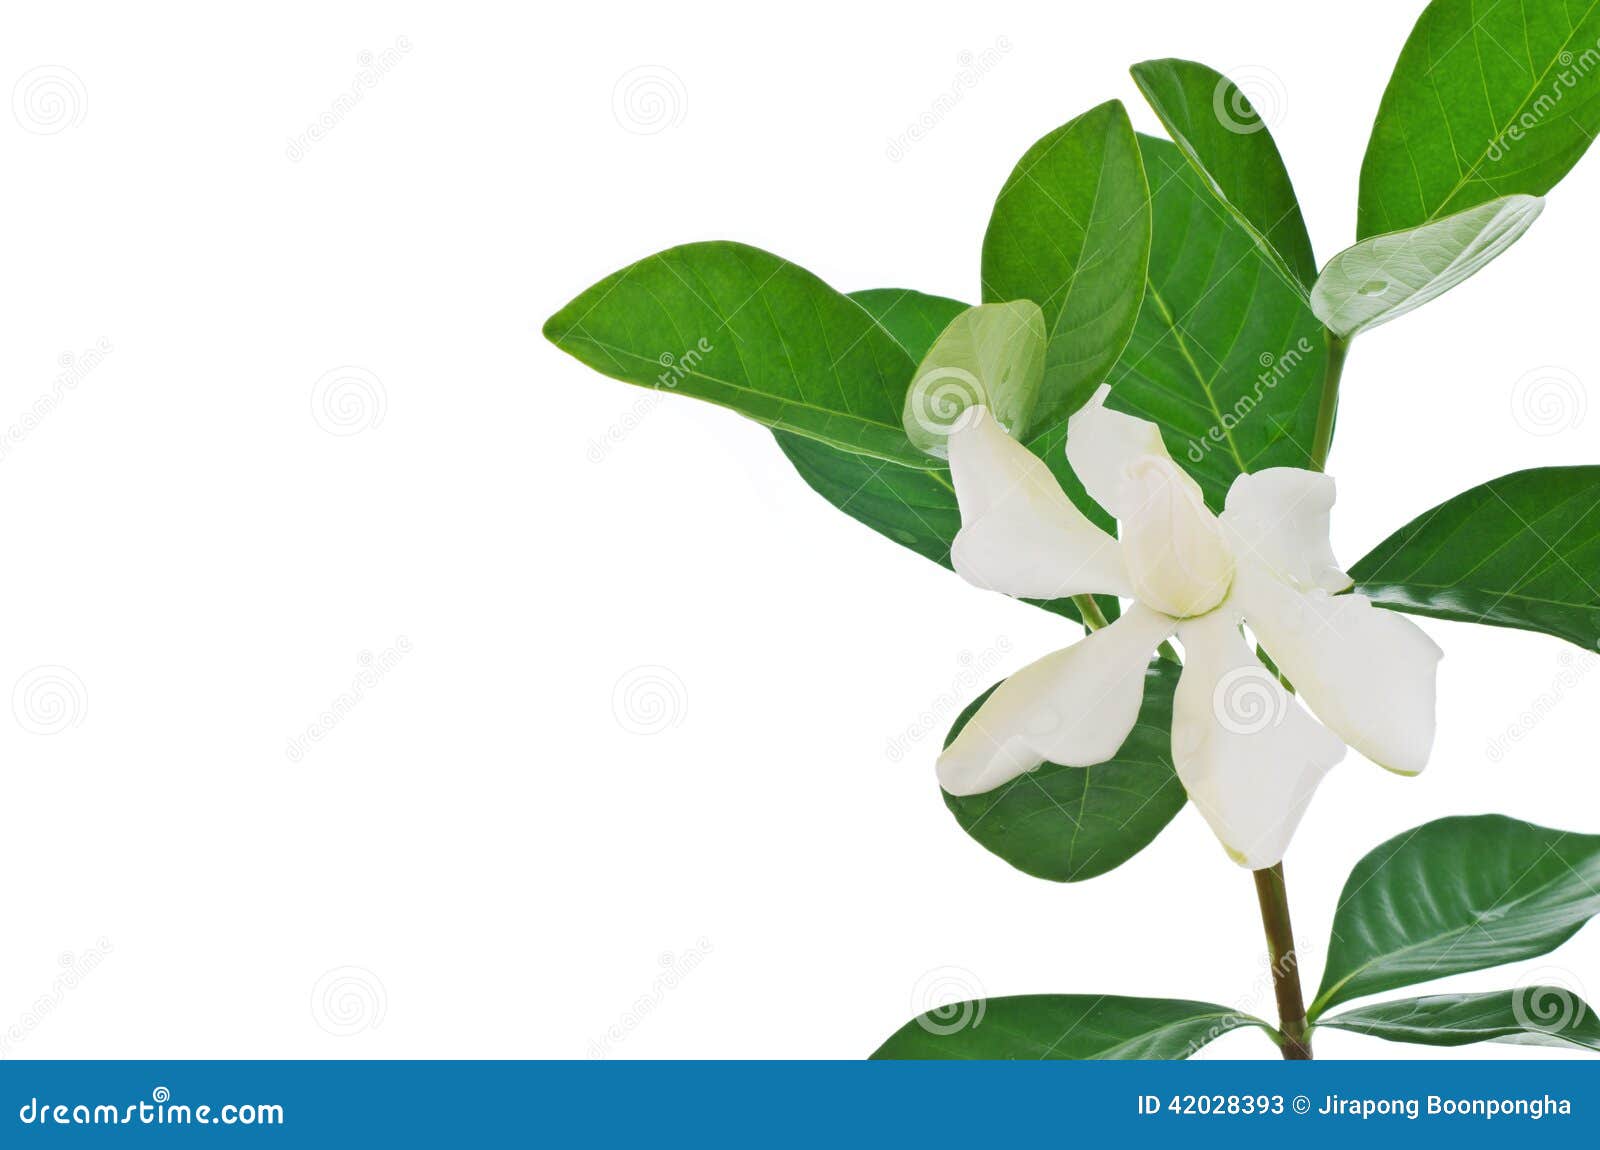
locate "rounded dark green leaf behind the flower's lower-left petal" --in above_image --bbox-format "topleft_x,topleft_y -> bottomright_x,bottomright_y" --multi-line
944,659 -> 1189,883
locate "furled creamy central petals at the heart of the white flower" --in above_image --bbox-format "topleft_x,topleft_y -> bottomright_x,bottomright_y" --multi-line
1122,456 -> 1234,619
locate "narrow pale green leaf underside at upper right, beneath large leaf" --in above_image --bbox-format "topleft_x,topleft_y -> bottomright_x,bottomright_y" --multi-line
1310,195 -> 1544,337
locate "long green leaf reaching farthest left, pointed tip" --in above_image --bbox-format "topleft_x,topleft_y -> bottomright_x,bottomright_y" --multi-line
544,242 -> 933,467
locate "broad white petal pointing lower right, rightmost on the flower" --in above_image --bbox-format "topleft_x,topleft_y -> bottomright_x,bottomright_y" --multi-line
1235,563 -> 1443,774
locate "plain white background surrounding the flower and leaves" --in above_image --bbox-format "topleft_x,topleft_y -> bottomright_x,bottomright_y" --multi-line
0,0 -> 1600,1057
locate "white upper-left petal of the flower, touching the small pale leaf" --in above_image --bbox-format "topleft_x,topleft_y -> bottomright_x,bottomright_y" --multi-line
949,408 -> 1133,598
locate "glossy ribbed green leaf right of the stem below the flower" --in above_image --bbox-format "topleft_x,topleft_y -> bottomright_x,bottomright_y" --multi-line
1309,814 -> 1600,1017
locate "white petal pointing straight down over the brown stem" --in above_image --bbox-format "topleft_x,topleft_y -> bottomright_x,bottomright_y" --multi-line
1173,609 -> 1344,870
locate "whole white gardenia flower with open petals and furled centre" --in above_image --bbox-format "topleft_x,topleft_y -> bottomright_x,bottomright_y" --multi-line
939,387 -> 1442,868
